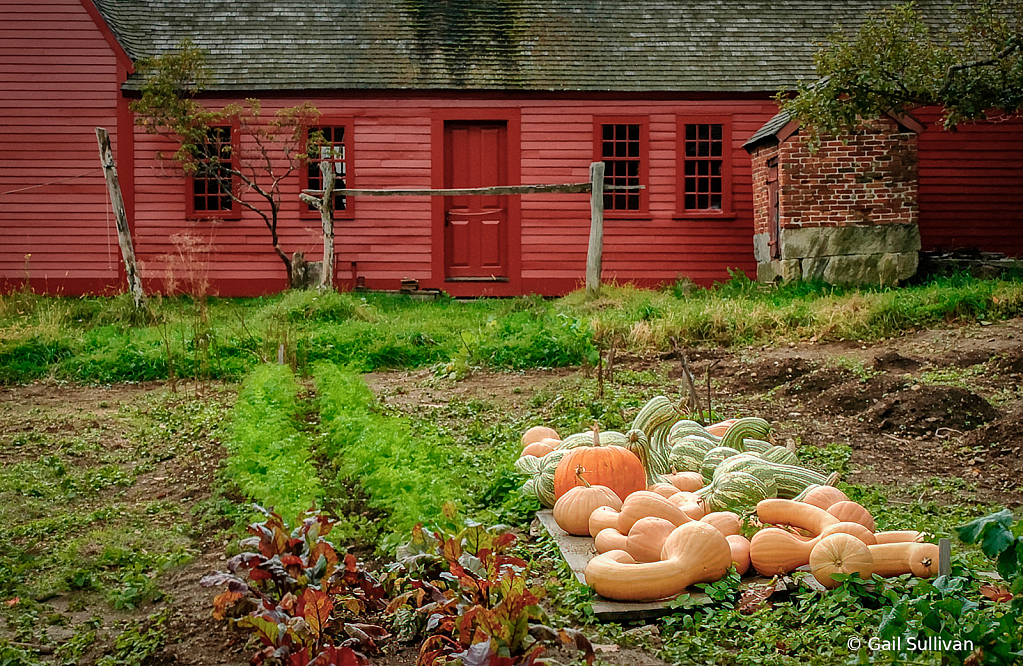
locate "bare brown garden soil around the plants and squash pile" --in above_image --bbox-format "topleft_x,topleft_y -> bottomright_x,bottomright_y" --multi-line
0,319 -> 1023,665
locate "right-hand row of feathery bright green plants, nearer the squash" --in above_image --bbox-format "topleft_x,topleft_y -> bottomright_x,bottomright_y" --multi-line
314,363 -> 497,548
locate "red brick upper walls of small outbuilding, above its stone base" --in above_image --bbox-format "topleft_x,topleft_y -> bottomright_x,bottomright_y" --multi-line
773,119 -> 918,229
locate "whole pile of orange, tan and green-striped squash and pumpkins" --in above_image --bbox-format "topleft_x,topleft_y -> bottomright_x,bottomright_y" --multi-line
516,397 -> 938,602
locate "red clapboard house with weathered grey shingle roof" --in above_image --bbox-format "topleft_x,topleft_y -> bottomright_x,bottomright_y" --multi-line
0,0 -> 1023,296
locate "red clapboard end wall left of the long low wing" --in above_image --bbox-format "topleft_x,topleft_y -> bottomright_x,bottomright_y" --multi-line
0,0 -> 130,294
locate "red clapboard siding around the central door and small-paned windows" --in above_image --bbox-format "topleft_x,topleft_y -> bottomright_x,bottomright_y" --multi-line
134,95 -> 775,295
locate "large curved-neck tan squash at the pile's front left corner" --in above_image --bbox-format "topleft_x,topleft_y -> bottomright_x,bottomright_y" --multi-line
584,521 -> 731,602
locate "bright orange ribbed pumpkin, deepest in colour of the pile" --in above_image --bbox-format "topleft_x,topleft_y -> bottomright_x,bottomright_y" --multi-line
554,446 -> 647,499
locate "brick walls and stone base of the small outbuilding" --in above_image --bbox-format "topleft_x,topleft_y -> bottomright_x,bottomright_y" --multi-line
751,119 -> 920,284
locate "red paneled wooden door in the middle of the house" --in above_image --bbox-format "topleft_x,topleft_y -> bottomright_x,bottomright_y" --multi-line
444,122 -> 509,281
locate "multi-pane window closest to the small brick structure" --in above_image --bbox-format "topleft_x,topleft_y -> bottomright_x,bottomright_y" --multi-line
682,123 -> 725,211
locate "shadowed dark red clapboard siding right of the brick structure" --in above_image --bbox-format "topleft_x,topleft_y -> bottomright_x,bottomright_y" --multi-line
914,109 -> 1023,256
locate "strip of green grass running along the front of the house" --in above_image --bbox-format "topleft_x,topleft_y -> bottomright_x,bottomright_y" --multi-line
0,275 -> 1023,384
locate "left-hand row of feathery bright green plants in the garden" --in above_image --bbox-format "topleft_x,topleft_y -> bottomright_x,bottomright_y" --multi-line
225,364 -> 322,520
